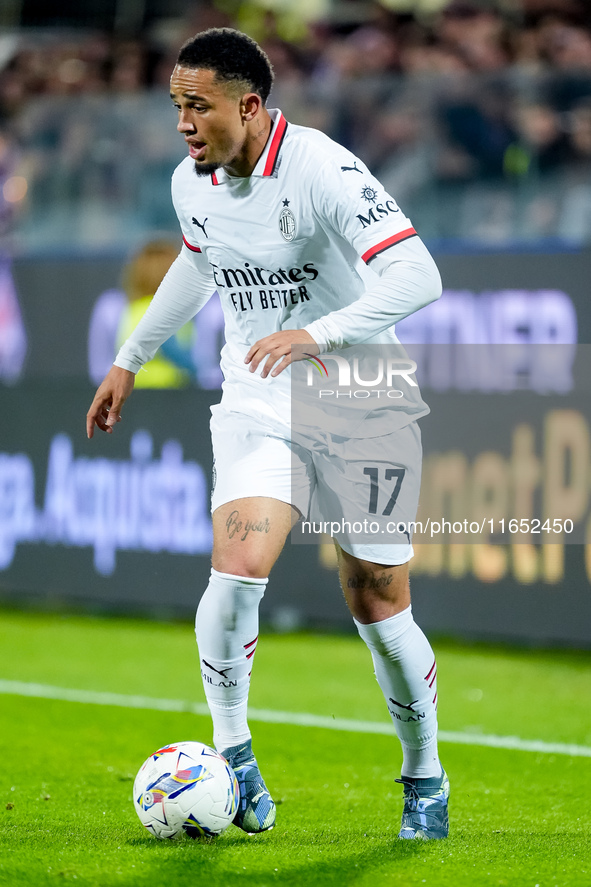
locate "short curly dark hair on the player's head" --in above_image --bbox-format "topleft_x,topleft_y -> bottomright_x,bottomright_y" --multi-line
177,28 -> 273,104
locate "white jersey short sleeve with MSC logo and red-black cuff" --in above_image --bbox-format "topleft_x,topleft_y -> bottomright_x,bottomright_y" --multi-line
313,152 -> 416,263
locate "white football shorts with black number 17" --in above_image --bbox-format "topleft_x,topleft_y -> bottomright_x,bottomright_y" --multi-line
210,404 -> 422,565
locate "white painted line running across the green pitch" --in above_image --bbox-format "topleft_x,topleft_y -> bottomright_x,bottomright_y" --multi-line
0,680 -> 591,758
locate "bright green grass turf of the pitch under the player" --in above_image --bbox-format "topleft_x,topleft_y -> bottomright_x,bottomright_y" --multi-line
0,612 -> 591,887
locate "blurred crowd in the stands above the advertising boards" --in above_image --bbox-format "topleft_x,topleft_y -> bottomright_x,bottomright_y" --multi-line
0,0 -> 591,246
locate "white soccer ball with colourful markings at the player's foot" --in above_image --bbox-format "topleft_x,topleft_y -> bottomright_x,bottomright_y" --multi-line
133,742 -> 240,838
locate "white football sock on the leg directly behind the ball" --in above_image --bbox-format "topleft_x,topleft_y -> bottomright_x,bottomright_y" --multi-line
195,569 -> 268,751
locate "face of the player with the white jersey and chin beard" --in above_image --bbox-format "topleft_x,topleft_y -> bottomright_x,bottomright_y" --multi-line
170,65 -> 252,175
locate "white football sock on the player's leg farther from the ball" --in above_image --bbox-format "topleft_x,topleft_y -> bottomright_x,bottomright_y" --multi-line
354,607 -> 441,779
